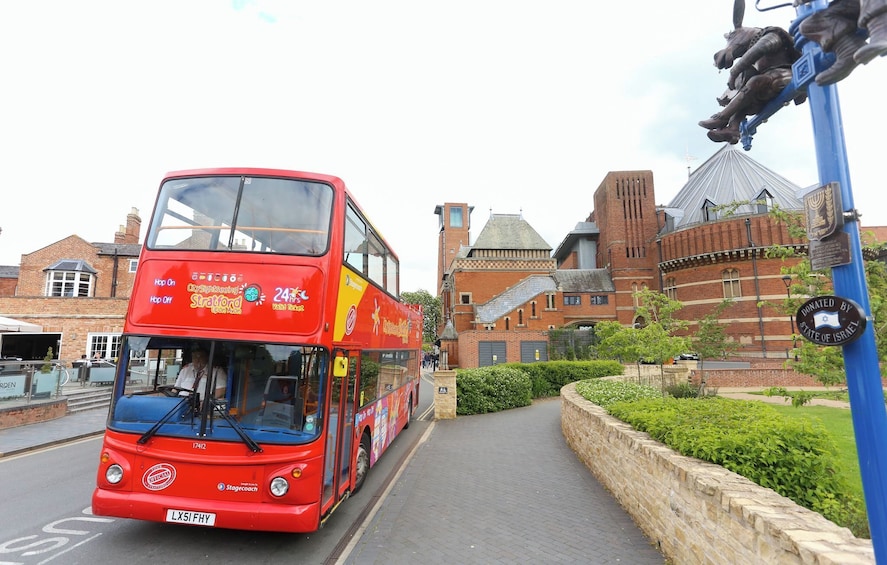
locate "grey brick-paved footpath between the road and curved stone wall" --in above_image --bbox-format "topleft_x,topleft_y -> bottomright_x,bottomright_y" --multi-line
344,398 -> 665,565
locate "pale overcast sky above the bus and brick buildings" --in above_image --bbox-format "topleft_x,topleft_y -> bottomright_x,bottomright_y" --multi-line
0,0 -> 887,292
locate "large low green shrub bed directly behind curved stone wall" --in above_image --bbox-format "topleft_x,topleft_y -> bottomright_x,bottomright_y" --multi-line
605,397 -> 864,535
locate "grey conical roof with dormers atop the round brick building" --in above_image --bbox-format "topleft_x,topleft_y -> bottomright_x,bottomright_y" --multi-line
668,145 -> 804,228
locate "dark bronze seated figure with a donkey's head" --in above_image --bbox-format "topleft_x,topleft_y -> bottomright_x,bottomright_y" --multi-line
699,0 -> 808,144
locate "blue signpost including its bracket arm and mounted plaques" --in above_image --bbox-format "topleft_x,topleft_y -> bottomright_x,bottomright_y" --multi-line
740,0 -> 887,563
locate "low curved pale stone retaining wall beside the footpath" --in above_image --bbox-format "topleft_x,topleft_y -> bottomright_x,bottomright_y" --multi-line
561,383 -> 875,565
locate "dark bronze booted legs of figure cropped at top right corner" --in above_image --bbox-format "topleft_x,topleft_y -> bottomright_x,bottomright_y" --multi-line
795,0 -> 887,86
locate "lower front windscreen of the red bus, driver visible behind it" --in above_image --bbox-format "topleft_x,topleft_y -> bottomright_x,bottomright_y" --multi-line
108,336 -> 329,445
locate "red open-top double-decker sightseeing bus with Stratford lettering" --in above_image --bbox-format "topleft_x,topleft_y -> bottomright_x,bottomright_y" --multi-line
92,168 -> 422,532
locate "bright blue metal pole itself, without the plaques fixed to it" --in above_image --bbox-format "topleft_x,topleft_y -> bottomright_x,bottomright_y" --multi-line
797,0 -> 887,563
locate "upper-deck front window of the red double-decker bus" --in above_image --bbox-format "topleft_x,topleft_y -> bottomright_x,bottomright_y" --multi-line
146,176 -> 333,256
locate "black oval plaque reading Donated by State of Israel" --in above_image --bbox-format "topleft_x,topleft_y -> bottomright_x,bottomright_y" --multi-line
795,296 -> 866,345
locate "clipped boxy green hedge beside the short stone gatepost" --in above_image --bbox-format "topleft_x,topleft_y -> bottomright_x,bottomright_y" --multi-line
456,365 -> 533,416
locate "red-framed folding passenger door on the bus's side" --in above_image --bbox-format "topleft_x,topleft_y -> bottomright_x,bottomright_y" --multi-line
321,349 -> 360,513
